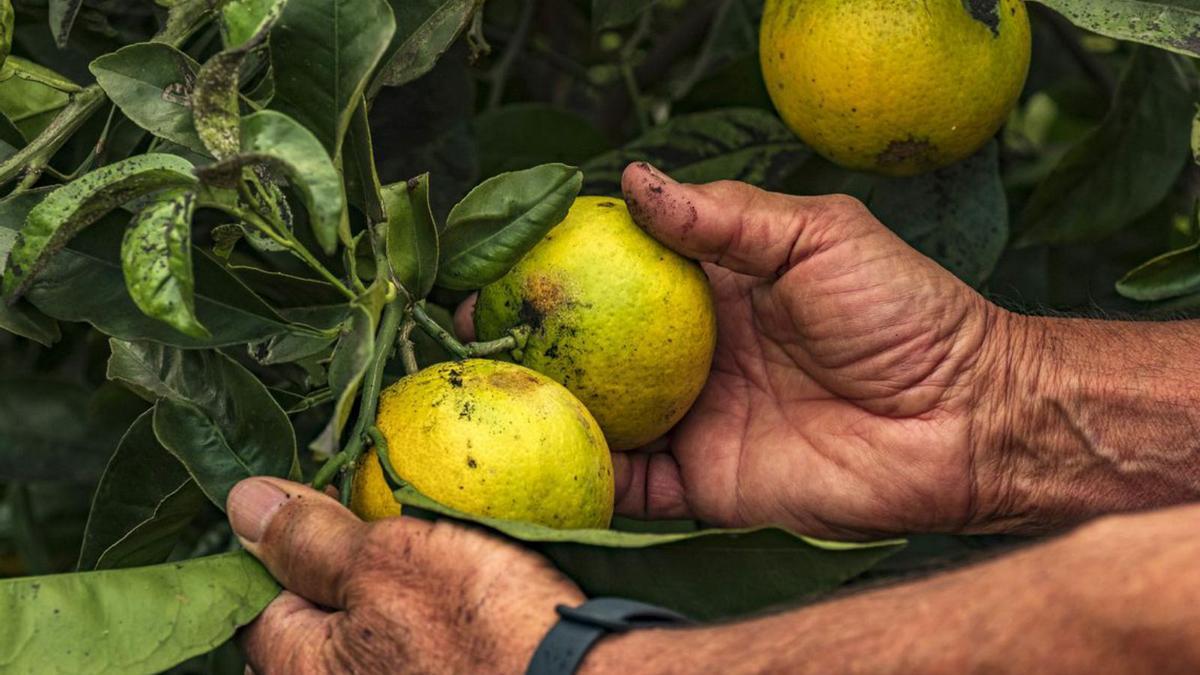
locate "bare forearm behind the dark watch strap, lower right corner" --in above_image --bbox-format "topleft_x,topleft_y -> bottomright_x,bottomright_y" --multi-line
584,509 -> 1200,675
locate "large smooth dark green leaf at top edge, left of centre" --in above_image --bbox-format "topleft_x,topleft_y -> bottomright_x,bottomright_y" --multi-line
270,0 -> 396,157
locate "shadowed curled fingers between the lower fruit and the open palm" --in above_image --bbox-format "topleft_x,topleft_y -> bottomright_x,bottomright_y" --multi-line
612,453 -> 692,520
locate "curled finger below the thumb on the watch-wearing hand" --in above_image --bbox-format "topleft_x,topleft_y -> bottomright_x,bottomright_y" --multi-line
241,591 -> 335,675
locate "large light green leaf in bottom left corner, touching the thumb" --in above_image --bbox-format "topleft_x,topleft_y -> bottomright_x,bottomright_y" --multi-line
0,551 -> 278,675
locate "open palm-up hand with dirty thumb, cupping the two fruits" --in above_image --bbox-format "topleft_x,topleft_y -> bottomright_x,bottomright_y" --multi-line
614,163 -> 1015,537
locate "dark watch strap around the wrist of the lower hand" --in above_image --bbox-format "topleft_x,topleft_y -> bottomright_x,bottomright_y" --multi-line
526,598 -> 691,675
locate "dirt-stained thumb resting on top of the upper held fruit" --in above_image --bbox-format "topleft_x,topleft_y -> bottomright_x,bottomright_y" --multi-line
622,162 -> 882,277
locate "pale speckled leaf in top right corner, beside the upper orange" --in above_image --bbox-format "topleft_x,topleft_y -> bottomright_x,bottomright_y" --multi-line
1036,0 -> 1200,56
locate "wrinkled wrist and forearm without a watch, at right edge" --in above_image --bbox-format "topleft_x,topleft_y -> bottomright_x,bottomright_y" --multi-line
974,315 -> 1200,531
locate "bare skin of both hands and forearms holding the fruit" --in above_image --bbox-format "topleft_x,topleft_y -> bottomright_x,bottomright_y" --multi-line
238,165 -> 1200,673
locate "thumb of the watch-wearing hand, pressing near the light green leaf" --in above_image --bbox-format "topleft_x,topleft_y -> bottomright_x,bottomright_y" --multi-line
227,477 -> 367,609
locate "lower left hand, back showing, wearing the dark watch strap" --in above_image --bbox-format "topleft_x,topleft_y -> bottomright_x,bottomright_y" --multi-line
228,478 -> 584,675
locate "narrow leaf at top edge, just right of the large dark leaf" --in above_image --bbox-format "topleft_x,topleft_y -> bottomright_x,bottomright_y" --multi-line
367,0 -> 484,98
